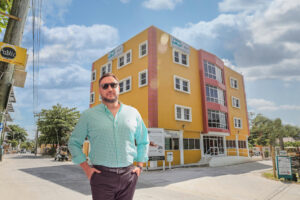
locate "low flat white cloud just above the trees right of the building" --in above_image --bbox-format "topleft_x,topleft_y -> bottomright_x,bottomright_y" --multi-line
247,98 -> 300,111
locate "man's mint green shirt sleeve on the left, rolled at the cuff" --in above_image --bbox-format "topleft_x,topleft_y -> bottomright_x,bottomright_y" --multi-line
68,113 -> 88,164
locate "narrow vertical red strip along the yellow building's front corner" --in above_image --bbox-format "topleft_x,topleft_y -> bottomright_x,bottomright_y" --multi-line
148,26 -> 158,128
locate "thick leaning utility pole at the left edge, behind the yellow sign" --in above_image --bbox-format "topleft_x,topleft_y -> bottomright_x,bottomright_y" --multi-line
0,0 -> 30,122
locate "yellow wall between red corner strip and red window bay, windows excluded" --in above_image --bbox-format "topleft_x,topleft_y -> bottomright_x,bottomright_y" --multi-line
157,29 -> 203,132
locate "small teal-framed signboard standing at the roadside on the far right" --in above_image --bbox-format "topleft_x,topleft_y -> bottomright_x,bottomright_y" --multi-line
276,156 -> 293,179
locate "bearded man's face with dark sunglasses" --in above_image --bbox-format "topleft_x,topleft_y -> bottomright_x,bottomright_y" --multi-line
99,76 -> 120,103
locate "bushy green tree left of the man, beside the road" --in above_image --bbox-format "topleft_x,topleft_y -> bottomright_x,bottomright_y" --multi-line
37,104 -> 80,146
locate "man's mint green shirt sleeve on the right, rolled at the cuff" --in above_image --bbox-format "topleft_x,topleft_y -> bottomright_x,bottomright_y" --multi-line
135,118 -> 149,162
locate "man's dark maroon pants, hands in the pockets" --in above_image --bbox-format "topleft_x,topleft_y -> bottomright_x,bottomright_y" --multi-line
90,165 -> 138,200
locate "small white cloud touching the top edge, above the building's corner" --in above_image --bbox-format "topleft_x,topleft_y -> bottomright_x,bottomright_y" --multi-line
143,0 -> 183,10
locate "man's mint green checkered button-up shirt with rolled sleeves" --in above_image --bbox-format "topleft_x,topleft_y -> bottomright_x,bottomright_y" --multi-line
69,103 -> 149,167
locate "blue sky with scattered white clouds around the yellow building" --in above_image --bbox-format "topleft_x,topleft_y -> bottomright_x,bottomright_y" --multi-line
0,0 -> 300,138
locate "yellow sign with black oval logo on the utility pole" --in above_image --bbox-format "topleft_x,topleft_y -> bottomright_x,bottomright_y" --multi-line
0,42 -> 27,66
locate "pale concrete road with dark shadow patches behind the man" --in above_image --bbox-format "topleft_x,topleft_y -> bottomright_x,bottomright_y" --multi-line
0,154 -> 300,200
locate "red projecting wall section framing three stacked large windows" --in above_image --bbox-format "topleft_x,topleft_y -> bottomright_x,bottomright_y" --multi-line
198,50 -> 230,133
